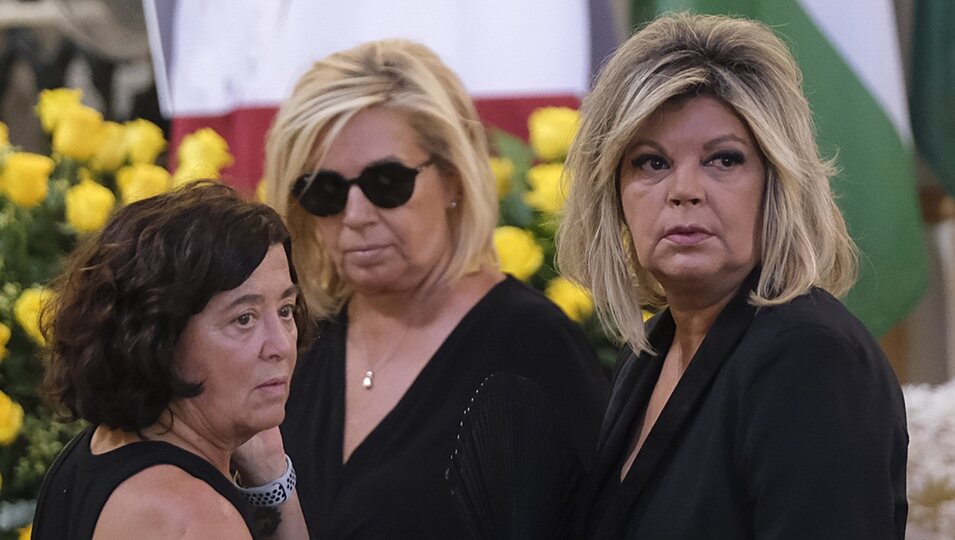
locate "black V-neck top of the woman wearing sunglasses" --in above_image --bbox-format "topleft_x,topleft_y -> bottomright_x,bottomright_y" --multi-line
282,277 -> 608,540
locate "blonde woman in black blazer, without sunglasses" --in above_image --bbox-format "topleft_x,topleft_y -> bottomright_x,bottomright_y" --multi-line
558,14 -> 907,539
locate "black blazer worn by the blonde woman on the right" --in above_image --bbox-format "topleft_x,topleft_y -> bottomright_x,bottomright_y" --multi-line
578,276 -> 908,540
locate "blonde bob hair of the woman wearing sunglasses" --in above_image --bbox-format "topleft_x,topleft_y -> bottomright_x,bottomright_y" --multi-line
265,39 -> 497,318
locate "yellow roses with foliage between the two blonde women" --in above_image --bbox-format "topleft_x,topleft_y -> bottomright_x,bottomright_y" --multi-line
491,107 -> 619,366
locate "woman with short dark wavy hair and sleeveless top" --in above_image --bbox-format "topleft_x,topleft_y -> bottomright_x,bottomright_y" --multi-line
33,182 -> 307,539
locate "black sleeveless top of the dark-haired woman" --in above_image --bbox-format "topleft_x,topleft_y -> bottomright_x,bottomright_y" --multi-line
32,427 -> 251,540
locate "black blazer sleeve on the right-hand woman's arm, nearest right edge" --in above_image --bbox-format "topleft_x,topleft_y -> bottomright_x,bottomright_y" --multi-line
738,327 -> 908,539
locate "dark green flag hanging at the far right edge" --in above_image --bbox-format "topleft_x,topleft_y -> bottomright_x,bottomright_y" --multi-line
909,0 -> 955,196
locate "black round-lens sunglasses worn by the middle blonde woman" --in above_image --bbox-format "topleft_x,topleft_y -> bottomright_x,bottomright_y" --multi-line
292,158 -> 434,217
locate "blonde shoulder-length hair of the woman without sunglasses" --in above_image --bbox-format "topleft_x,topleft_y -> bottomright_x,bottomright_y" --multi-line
557,13 -> 858,351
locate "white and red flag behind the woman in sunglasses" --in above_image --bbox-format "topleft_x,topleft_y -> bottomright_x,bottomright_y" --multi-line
144,0 -> 615,194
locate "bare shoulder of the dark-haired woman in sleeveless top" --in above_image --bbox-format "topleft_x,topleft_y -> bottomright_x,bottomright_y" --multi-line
95,465 -> 250,540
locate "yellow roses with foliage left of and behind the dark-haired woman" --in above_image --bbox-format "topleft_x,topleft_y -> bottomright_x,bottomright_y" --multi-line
0,88 -> 232,539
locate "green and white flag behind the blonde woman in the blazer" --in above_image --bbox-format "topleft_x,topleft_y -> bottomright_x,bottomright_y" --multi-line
631,0 -> 928,336
